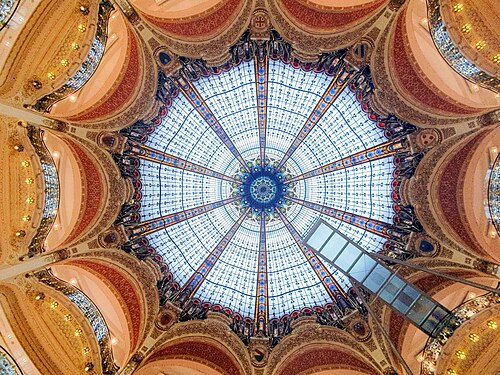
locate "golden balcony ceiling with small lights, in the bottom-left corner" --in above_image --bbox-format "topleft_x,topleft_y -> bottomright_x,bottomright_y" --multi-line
0,280 -> 96,375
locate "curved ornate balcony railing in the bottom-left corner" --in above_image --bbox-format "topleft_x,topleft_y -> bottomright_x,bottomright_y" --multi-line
34,270 -> 119,375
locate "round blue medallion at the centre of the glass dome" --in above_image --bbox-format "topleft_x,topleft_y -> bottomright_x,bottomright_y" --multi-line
238,164 -> 288,215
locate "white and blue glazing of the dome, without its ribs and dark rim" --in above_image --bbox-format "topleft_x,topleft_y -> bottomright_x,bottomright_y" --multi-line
127,51 -> 404,319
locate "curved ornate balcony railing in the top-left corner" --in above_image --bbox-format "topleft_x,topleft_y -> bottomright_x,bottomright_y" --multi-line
31,0 -> 114,112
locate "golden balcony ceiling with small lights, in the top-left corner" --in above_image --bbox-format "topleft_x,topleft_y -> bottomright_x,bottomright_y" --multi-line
0,0 -> 97,105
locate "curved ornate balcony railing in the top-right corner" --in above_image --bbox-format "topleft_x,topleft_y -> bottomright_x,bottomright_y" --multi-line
427,0 -> 500,92
